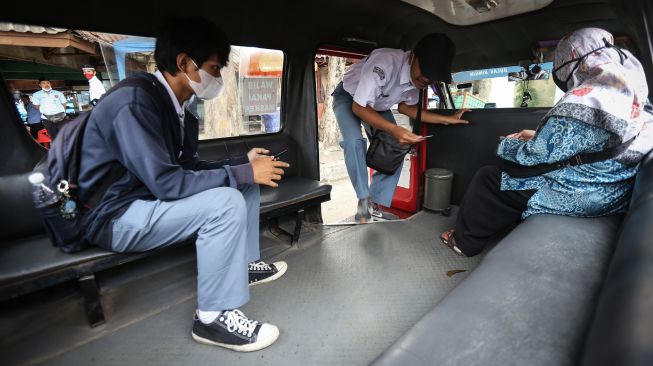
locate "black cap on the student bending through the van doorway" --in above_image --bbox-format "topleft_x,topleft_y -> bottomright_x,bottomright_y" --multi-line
413,33 -> 456,83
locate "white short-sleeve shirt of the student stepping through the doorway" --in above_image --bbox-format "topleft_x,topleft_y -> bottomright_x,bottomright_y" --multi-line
342,48 -> 419,111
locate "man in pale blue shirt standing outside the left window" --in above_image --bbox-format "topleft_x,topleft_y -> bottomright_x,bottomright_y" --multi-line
32,76 -> 67,140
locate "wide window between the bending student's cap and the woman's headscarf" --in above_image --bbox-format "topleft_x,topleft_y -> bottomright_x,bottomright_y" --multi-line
450,62 -> 564,109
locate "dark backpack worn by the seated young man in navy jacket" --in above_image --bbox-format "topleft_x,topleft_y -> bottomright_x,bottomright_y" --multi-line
37,75 -> 161,253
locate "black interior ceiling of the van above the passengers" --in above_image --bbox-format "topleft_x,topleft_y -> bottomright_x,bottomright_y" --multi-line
0,0 -> 642,71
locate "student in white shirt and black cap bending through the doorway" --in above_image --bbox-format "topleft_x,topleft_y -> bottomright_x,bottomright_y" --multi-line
332,33 -> 468,223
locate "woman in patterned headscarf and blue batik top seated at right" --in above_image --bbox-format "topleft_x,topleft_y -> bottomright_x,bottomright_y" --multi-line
440,28 -> 653,256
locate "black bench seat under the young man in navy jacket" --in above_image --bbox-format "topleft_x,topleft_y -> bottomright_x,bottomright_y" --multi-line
0,175 -> 331,326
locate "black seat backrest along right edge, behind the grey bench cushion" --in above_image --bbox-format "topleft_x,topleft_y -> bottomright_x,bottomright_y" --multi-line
582,153 -> 653,366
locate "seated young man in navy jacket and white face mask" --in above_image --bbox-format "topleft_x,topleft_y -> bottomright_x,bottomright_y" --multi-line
79,17 -> 289,351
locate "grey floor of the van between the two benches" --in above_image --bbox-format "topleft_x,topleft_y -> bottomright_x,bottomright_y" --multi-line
0,210 -> 482,366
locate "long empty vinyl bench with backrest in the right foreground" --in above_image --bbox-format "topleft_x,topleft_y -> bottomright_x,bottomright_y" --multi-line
373,153 -> 653,366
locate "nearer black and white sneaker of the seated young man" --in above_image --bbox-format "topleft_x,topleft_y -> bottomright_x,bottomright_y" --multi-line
192,309 -> 279,352
